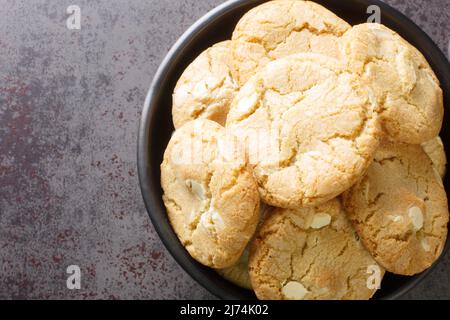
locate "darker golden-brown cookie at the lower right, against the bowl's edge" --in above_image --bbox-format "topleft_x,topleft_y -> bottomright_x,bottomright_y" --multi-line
344,141 -> 449,275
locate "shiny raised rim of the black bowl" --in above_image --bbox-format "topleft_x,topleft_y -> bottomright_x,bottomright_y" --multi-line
137,0 -> 450,300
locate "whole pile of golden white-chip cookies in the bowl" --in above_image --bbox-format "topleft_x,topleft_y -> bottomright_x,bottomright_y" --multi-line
161,0 -> 449,299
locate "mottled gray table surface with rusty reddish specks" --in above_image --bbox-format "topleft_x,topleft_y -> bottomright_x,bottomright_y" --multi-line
0,0 -> 450,299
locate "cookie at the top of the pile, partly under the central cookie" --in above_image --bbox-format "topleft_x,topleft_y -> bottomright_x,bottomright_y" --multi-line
231,0 -> 350,86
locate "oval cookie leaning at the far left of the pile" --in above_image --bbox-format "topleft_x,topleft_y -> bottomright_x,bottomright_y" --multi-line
161,119 -> 260,268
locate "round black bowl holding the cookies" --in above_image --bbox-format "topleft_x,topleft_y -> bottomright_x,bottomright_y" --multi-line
138,0 -> 450,299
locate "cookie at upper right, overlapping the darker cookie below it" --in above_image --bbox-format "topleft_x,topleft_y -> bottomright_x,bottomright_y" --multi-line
341,23 -> 444,144
